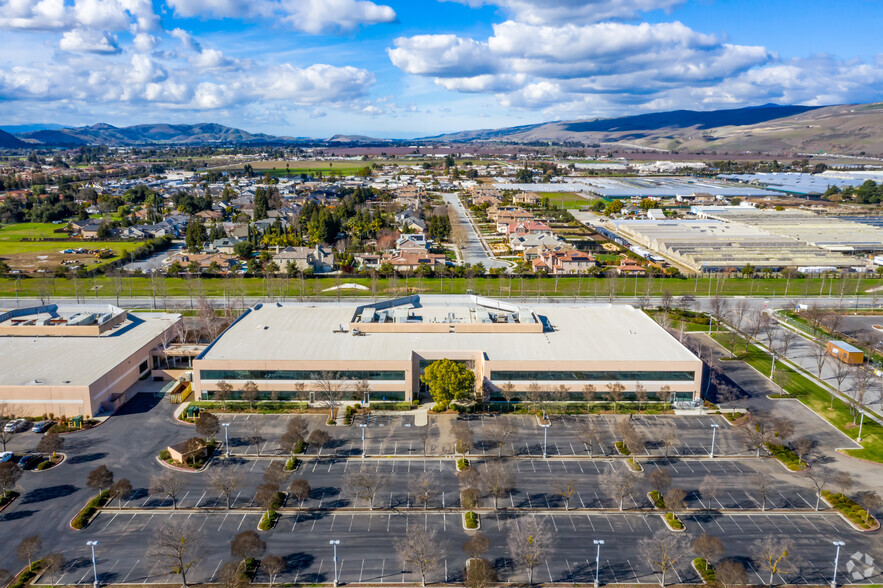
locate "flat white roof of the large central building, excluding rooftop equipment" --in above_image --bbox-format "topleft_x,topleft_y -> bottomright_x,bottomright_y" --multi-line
200,296 -> 698,362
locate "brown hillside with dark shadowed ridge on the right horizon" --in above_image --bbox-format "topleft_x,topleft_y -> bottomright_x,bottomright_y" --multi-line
423,103 -> 883,154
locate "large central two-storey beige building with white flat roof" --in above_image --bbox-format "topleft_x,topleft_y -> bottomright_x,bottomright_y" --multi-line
193,296 -> 702,401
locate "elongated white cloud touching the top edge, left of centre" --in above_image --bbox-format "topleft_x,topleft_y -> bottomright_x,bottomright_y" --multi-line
168,0 -> 396,35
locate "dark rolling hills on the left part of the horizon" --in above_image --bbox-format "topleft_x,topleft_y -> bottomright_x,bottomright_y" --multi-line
17,123 -> 284,147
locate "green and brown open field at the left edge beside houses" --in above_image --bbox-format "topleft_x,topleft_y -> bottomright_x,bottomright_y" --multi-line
0,223 -> 140,272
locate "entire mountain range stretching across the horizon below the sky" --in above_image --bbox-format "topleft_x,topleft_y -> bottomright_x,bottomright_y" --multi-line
0,103 -> 883,155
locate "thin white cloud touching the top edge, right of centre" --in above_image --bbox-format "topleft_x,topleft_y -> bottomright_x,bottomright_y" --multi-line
447,0 -> 685,25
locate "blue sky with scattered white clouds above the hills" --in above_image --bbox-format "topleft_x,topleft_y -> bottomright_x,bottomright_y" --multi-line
0,0 -> 883,138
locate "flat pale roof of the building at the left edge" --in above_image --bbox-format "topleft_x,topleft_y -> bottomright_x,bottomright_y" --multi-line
0,313 -> 180,386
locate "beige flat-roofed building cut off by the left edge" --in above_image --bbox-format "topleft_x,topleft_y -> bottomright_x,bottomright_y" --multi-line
0,304 -> 182,417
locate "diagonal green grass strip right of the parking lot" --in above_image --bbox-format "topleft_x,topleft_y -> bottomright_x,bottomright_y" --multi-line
712,333 -> 883,463
